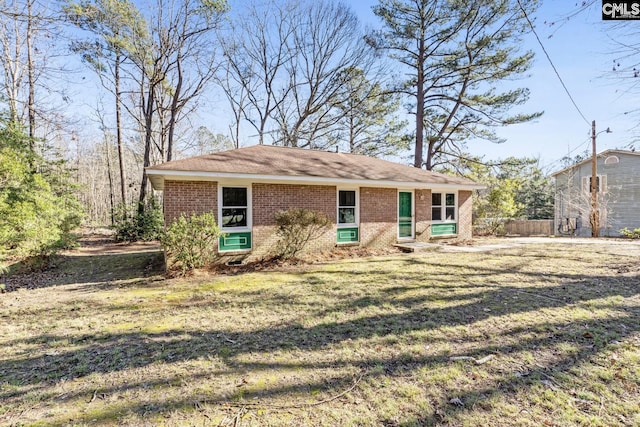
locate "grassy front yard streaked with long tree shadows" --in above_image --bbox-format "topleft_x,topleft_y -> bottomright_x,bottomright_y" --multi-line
0,239 -> 640,426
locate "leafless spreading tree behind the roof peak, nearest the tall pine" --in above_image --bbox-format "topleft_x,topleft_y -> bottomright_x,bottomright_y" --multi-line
276,1 -> 375,148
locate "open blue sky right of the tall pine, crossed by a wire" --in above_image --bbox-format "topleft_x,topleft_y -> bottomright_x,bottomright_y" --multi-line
356,0 -> 640,170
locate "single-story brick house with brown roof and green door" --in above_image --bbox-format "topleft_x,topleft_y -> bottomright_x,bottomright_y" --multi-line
147,145 -> 482,260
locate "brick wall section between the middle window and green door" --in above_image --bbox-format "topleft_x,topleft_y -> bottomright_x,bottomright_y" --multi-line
360,187 -> 398,247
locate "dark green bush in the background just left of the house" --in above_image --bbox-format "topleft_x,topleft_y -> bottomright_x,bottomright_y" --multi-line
114,197 -> 164,242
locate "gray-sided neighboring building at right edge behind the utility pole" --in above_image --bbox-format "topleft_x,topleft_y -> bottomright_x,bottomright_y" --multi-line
551,150 -> 640,236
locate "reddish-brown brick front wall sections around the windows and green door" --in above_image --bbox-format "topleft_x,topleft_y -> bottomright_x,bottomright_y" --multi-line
164,181 -> 472,260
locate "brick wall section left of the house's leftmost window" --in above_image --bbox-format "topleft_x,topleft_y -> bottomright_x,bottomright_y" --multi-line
163,181 -> 218,225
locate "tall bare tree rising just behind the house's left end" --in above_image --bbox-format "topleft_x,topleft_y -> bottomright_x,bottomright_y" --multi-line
134,0 -> 227,211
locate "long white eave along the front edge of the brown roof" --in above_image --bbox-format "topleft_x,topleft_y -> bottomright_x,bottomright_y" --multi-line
147,169 -> 486,190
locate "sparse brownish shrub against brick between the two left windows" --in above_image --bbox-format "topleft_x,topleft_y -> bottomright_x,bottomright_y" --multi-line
275,208 -> 331,259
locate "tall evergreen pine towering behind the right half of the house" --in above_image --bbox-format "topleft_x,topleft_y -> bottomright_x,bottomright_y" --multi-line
369,0 -> 540,169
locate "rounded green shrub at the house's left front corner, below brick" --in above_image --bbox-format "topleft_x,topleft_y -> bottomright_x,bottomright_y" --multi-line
162,213 -> 220,274
